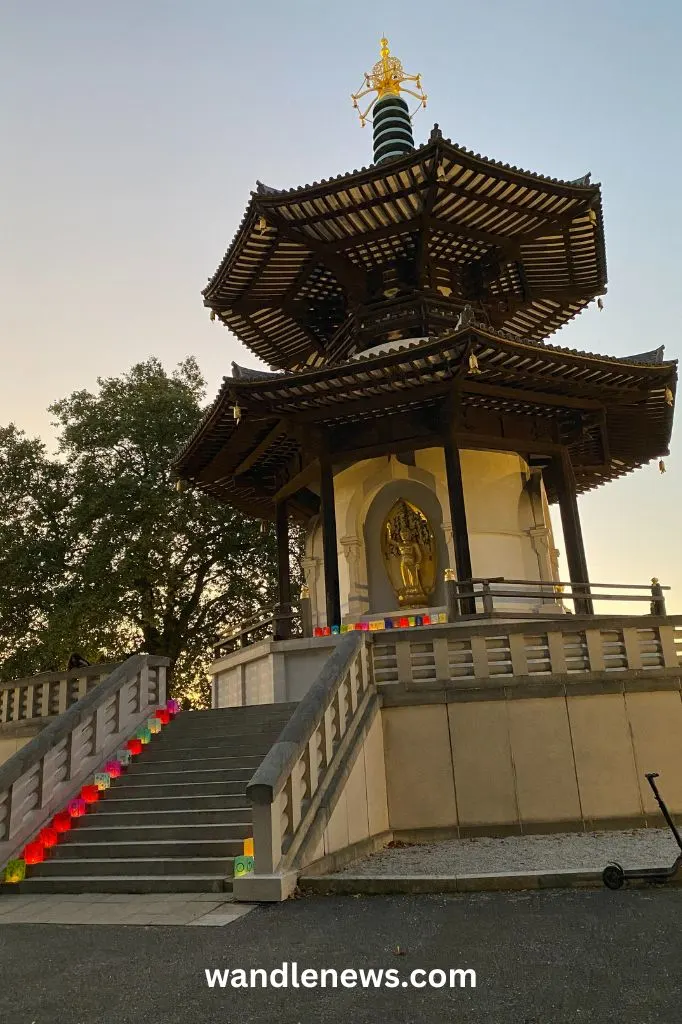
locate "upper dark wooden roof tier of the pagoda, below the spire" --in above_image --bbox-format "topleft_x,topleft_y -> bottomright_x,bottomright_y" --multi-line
204,127 -> 606,370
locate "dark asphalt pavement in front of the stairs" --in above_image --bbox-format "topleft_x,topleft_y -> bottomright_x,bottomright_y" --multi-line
0,888 -> 682,1024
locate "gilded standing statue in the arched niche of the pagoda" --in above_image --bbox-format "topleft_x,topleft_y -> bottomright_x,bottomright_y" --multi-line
382,498 -> 436,608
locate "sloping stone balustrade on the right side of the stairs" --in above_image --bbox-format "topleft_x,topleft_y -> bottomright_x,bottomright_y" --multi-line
247,631 -> 374,876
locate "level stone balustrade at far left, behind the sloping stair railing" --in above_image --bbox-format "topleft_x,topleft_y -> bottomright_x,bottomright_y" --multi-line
0,662 -> 120,730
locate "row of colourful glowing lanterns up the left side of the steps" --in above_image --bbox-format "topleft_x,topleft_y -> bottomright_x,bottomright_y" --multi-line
2,698 -> 180,883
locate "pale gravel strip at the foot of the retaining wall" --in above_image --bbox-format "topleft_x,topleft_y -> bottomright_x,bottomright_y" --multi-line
340,828 -> 680,876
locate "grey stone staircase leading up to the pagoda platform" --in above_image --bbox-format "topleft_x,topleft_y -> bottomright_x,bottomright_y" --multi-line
12,703 -> 296,893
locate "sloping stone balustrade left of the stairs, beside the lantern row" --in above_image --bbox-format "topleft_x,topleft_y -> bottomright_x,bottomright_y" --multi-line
0,654 -> 170,866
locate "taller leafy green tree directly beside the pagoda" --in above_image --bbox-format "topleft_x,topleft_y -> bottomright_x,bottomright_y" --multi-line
0,358 -> 303,699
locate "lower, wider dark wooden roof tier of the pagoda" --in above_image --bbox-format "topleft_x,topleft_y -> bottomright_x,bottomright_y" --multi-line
174,324 -> 677,518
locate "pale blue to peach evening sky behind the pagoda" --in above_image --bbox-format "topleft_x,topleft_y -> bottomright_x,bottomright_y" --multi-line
0,0 -> 682,612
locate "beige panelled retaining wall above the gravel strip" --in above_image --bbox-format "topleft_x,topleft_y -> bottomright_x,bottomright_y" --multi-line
382,680 -> 682,835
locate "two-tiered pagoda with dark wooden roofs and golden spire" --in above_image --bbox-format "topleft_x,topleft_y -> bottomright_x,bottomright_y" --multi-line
174,39 -> 677,639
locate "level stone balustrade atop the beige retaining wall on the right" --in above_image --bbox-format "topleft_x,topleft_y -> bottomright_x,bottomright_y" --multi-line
372,615 -> 682,692
